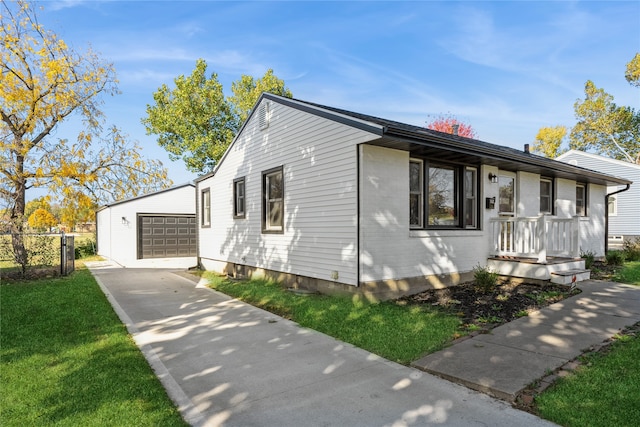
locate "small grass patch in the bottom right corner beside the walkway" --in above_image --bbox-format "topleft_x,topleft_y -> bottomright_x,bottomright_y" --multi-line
536,328 -> 640,427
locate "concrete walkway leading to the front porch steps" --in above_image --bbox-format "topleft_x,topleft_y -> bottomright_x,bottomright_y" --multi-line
412,280 -> 640,401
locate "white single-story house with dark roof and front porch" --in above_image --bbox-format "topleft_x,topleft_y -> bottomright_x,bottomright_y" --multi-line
196,94 -> 628,297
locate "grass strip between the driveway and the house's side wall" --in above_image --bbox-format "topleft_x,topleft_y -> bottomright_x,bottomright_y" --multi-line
205,273 -> 461,364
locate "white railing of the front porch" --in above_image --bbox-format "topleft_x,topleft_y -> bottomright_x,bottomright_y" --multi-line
490,216 -> 580,263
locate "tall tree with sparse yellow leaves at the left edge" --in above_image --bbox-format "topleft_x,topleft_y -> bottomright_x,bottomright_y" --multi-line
0,0 -> 170,272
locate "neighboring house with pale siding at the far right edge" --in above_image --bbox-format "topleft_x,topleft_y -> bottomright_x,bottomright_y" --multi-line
557,150 -> 640,247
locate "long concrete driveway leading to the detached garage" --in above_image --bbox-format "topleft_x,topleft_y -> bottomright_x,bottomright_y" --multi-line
88,262 -> 553,427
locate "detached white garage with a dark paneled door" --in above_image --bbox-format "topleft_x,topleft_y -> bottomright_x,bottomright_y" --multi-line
96,183 -> 197,268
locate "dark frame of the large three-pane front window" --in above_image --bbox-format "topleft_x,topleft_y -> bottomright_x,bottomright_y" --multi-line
408,157 -> 481,231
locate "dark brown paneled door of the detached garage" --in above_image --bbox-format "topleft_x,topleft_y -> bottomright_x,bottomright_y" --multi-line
138,215 -> 196,259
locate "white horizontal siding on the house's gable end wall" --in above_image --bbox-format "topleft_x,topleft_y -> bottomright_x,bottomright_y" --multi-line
198,102 -> 377,285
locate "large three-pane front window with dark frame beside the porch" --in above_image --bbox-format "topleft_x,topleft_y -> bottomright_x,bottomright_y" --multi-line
409,159 -> 478,228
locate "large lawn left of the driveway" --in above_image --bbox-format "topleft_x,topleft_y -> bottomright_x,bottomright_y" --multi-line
0,266 -> 187,427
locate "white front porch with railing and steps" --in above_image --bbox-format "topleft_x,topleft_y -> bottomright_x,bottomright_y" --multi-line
487,215 -> 590,284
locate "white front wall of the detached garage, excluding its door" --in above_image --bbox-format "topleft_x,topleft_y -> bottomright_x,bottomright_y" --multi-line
97,184 -> 196,268
